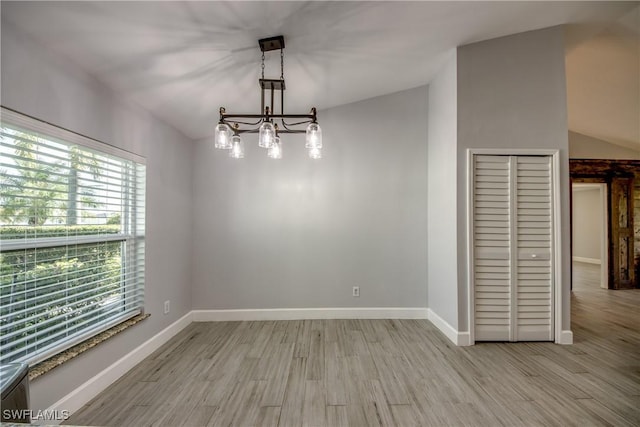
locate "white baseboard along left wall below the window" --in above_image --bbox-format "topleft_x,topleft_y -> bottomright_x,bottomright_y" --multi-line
45,311 -> 193,425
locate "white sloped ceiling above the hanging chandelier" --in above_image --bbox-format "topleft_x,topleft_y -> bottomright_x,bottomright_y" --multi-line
1,1 -> 640,144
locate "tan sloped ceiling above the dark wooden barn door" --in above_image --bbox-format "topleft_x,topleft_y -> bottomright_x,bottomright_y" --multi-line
566,2 -> 640,151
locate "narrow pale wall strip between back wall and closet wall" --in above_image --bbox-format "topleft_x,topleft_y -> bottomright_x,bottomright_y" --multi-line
428,50 -> 464,329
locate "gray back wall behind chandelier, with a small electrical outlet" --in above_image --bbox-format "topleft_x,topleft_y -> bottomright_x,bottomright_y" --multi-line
193,87 -> 427,309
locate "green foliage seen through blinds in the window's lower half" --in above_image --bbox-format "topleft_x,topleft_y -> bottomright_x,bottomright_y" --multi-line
0,225 -> 123,358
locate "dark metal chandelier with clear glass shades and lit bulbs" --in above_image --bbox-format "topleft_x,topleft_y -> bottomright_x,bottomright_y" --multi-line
214,36 -> 322,159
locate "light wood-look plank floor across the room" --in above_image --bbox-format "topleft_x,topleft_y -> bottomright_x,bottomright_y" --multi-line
67,264 -> 640,426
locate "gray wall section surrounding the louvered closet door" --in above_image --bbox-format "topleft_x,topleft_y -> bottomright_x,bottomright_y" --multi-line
457,27 -> 570,330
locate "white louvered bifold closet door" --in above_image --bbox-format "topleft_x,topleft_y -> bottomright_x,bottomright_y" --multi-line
473,155 -> 553,341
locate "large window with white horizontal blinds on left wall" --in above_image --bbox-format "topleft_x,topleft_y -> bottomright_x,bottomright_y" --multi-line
0,108 -> 145,364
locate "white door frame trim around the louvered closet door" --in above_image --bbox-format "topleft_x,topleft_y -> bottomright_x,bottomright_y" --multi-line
466,148 -> 572,345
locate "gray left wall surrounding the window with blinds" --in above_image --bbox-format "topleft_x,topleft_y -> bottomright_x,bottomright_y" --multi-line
1,21 -> 193,410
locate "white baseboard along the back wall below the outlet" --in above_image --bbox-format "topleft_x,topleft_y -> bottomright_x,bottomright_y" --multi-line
191,307 -> 428,322
